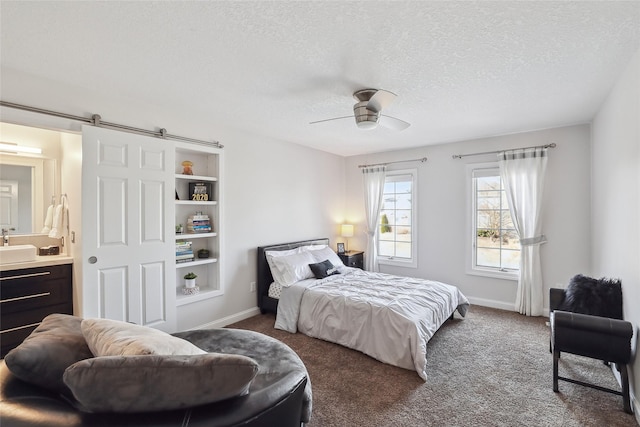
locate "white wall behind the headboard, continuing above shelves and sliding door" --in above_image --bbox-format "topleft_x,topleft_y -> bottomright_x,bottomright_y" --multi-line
1,68 -> 344,329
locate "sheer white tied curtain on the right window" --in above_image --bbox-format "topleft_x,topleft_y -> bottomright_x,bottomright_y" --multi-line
498,147 -> 547,316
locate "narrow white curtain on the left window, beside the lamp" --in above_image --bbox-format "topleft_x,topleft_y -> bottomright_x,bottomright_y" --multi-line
362,166 -> 386,271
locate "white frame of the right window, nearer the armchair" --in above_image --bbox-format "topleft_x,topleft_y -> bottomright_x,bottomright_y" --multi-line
465,162 -> 522,281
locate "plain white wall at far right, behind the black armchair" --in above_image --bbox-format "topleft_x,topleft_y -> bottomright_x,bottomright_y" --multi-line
591,47 -> 640,422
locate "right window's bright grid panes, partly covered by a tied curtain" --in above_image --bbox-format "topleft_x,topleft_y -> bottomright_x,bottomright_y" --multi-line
470,164 -> 520,277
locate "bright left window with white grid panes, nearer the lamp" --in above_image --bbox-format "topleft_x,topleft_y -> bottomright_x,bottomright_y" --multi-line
377,170 -> 417,267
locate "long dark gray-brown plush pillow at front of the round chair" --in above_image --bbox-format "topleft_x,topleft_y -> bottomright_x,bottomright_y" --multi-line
64,353 -> 258,412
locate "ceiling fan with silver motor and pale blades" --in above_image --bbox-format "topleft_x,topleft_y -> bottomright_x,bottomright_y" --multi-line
310,89 -> 411,130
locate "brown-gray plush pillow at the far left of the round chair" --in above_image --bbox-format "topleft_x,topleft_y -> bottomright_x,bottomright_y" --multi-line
4,314 -> 93,395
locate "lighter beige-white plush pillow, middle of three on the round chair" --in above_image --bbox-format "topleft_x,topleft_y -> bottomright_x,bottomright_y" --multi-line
81,319 -> 206,356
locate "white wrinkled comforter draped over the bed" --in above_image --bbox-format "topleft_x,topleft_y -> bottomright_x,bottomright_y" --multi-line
275,267 -> 469,380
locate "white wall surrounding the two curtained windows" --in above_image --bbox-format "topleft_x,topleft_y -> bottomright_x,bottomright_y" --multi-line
346,124 -> 590,310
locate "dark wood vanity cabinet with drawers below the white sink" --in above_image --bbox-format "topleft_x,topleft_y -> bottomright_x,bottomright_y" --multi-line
0,264 -> 73,357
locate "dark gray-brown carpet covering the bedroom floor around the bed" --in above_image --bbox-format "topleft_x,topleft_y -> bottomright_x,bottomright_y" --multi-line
229,306 -> 637,427
